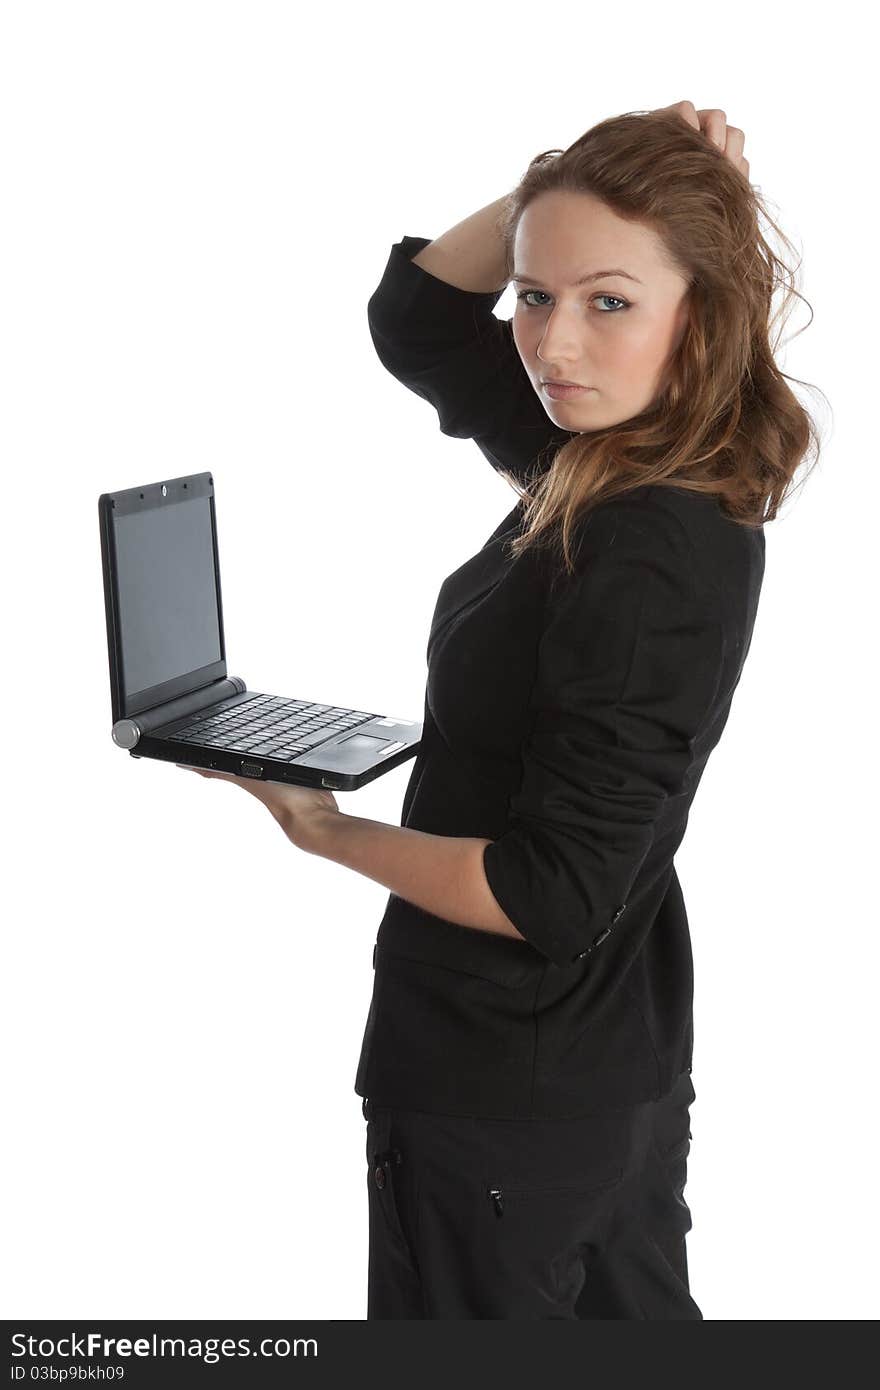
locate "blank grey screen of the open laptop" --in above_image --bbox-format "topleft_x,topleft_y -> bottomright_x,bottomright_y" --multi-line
114,496 -> 222,705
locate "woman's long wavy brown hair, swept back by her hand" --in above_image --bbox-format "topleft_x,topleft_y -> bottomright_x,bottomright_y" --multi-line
498,111 -> 820,574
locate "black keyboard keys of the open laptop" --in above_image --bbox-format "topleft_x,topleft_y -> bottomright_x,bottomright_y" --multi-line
164,695 -> 377,762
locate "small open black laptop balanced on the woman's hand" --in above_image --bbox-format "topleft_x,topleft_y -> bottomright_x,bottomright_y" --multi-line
97,473 -> 423,791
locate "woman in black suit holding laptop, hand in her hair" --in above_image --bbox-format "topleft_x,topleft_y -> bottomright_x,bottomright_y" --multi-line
177,101 -> 813,1319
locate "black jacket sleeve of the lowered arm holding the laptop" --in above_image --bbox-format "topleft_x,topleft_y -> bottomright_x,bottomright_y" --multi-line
482,499 -> 724,966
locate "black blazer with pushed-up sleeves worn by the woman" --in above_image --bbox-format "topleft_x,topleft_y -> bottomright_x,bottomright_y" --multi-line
355,236 -> 765,1118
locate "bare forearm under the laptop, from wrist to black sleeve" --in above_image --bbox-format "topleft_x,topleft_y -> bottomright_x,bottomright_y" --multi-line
293,810 -> 523,941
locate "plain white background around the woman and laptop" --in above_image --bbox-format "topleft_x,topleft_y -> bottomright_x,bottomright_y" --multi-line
0,0 -> 879,1319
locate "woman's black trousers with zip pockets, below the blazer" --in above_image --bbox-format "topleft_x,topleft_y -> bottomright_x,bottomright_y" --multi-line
363,1072 -> 702,1319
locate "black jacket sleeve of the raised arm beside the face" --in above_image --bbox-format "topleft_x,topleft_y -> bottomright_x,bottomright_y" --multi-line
367,236 -> 571,492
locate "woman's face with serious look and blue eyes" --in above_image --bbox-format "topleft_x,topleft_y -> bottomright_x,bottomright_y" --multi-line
512,190 -> 688,432
